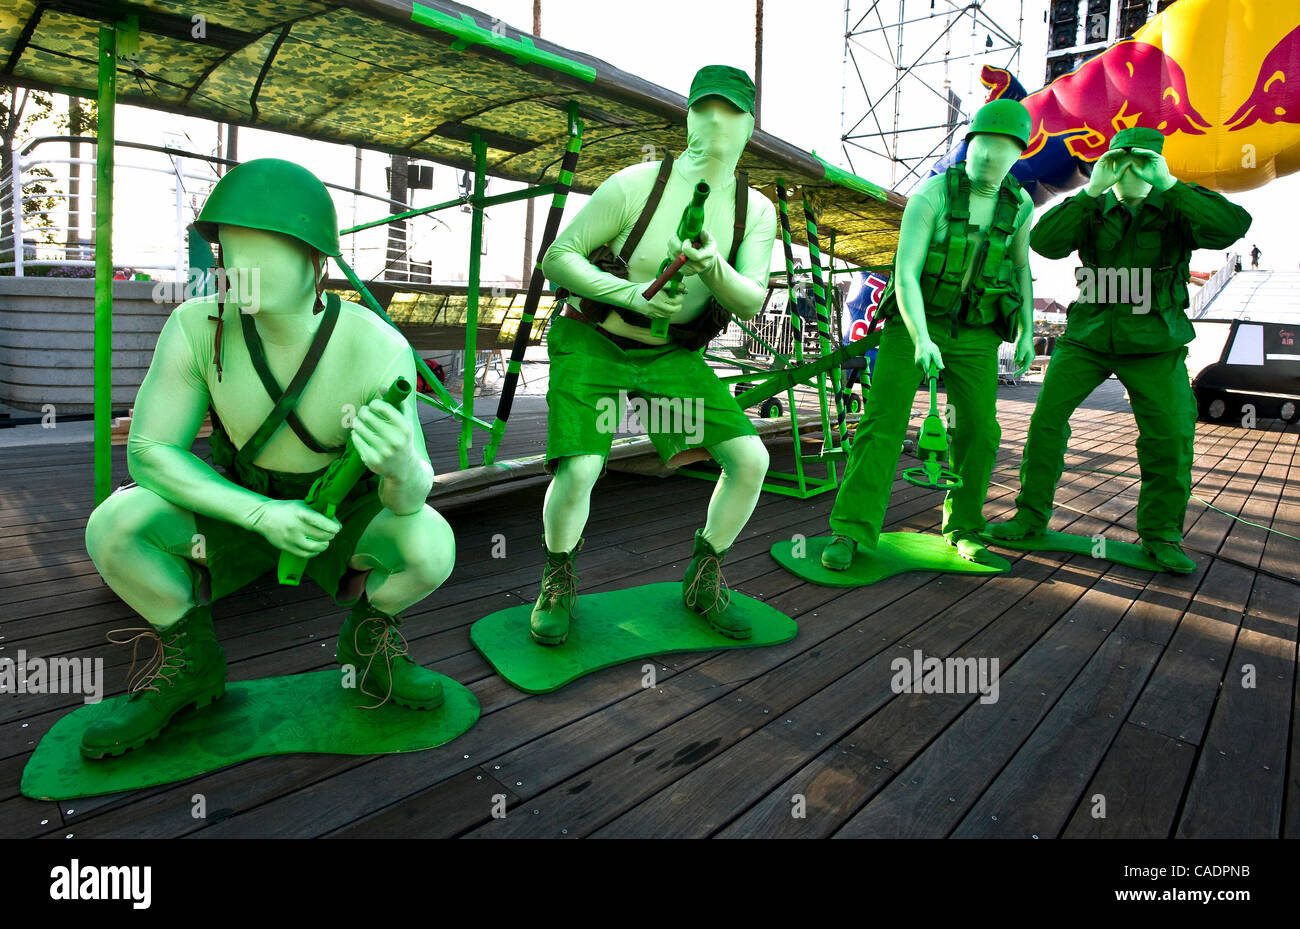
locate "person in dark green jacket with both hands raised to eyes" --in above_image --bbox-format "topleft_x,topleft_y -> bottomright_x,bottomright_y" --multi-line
991,127 -> 1251,573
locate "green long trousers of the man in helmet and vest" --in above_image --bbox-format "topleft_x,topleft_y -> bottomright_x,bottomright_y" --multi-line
831,318 -> 1002,548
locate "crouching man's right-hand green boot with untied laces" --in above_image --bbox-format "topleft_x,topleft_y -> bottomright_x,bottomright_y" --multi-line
335,595 -> 442,709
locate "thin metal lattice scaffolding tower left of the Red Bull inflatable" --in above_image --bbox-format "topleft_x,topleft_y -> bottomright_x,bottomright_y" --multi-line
840,0 -> 1024,192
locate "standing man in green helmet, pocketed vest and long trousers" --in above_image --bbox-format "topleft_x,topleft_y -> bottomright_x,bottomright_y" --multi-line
822,100 -> 1034,570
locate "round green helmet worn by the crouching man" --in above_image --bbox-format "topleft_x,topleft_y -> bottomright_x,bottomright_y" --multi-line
194,159 -> 342,257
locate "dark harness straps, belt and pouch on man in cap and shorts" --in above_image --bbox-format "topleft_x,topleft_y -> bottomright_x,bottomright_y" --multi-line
555,155 -> 749,352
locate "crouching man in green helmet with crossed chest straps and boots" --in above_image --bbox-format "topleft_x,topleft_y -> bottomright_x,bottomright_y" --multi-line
81,159 -> 455,759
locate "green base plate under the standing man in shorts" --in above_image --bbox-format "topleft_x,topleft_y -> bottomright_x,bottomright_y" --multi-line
469,582 -> 800,694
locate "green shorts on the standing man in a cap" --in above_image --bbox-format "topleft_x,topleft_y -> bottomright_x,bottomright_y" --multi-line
546,314 -> 758,474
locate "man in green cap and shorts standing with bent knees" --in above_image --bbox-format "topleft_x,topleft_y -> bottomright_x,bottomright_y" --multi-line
530,65 -> 776,646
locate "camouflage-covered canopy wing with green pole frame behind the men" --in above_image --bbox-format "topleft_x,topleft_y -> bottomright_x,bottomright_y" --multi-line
0,0 -> 906,503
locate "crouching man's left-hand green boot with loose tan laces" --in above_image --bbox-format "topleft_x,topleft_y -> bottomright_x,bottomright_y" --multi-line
81,605 -> 226,759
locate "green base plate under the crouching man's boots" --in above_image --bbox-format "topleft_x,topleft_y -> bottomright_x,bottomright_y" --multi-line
22,670 -> 478,800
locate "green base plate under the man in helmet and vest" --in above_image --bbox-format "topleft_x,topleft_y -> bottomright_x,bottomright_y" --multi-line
772,533 -> 1010,587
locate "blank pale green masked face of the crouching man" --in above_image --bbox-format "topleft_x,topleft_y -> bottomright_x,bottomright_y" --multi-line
217,223 -> 316,316
